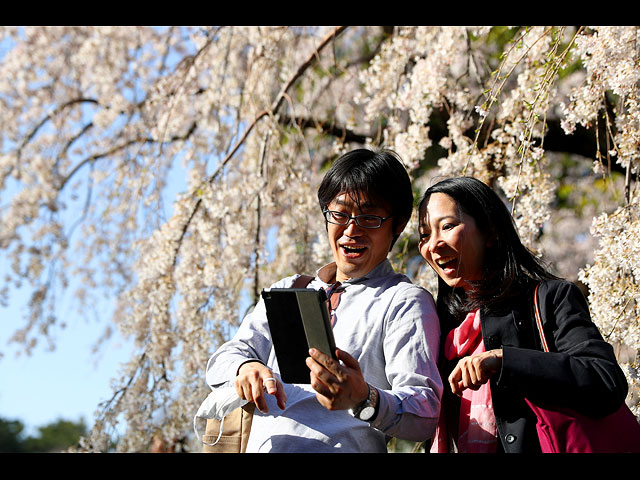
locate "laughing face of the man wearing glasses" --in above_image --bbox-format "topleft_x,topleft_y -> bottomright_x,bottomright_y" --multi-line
327,193 -> 394,282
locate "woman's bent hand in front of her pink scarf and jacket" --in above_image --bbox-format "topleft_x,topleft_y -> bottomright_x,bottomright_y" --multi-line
449,348 -> 502,396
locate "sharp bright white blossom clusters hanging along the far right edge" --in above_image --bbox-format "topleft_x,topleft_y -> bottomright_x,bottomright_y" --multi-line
563,26 -> 640,413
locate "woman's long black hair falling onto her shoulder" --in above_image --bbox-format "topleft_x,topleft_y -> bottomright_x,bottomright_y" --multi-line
419,177 -> 556,324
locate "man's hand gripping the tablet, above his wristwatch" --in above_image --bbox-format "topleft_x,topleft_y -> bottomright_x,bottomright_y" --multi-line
307,348 -> 369,410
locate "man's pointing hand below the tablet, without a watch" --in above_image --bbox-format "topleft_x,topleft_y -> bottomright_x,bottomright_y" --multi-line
235,362 -> 287,413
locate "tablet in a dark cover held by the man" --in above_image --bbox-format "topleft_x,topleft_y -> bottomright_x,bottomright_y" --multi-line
262,288 -> 336,383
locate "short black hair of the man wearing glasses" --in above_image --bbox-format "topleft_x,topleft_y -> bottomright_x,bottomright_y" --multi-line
318,148 -> 413,246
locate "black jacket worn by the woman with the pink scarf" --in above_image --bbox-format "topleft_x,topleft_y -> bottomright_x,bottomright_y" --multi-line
442,280 -> 628,453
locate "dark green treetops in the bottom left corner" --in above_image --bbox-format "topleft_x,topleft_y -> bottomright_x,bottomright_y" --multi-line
0,418 -> 87,453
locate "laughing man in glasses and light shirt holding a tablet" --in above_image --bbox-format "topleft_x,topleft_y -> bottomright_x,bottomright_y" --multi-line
207,149 -> 442,452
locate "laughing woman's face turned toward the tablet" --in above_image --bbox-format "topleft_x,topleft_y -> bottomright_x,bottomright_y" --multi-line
418,193 -> 487,289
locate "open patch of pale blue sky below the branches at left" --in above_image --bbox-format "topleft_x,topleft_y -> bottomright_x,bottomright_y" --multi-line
0,284 -> 130,435
